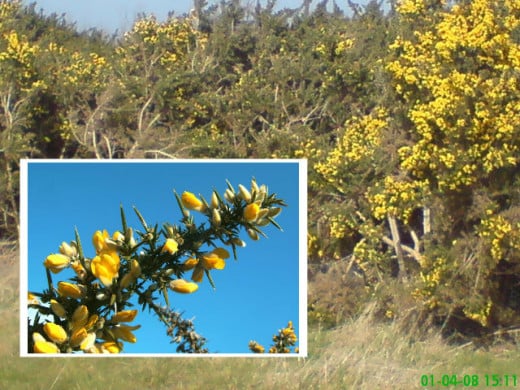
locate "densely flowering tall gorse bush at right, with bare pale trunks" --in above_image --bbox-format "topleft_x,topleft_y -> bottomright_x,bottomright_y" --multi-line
313,0 -> 520,335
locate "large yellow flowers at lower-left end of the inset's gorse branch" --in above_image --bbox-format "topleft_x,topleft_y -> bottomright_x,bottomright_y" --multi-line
32,230 -> 140,353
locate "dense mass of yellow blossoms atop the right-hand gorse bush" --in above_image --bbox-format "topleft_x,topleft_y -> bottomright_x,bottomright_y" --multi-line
387,0 -> 520,190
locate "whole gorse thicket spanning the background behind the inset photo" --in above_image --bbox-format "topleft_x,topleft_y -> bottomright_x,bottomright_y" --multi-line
4,0 -> 520,342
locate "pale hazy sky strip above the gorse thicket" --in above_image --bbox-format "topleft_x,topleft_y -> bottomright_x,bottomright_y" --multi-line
22,0 -> 324,33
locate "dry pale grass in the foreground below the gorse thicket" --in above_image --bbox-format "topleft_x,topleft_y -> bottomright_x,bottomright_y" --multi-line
4,242 -> 520,390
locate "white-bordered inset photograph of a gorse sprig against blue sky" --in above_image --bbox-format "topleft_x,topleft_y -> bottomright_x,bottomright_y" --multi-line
20,160 -> 307,357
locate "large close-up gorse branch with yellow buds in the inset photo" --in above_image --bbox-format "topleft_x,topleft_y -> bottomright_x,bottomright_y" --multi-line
28,179 -> 288,353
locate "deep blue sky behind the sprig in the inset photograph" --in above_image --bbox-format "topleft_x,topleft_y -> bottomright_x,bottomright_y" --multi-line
22,160 -> 306,353
